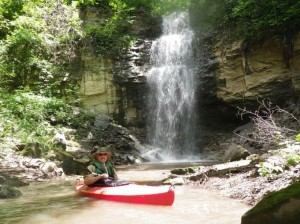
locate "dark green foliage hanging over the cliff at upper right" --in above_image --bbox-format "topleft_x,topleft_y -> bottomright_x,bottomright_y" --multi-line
192,0 -> 300,42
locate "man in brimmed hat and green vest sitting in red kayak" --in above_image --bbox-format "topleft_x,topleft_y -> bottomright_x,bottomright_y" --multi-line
84,146 -> 118,186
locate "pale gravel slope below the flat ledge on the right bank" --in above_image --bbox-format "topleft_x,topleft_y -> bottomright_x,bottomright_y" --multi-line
186,166 -> 300,206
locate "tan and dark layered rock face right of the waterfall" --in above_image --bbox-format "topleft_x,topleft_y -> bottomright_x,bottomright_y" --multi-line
190,32 -> 300,130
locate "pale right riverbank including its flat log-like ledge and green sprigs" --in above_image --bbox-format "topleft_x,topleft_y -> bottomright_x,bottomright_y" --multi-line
165,144 -> 300,206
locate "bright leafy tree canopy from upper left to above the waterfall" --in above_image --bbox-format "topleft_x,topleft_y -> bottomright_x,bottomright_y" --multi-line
0,0 -> 189,96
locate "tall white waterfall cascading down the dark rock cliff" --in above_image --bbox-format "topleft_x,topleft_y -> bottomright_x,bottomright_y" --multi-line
147,12 -> 196,160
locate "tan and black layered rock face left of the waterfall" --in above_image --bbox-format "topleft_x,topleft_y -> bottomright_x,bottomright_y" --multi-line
80,8 -> 160,126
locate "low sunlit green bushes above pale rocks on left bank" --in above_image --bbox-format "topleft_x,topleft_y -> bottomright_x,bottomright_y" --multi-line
0,91 -> 92,149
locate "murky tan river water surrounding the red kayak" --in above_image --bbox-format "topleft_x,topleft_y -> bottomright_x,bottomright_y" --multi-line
0,166 -> 250,224
